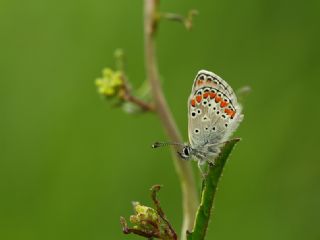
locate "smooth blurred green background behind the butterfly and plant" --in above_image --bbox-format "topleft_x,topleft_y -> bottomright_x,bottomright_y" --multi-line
0,0 -> 320,240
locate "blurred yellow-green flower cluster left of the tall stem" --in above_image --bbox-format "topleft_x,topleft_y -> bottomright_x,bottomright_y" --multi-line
95,68 -> 124,97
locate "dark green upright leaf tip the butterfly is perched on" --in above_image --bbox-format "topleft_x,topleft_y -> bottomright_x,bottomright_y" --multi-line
187,138 -> 240,240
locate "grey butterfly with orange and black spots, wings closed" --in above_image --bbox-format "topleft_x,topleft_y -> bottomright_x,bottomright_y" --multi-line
153,70 -> 243,165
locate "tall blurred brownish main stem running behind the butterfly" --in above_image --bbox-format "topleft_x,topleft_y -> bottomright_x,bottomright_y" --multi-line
144,0 -> 198,239
